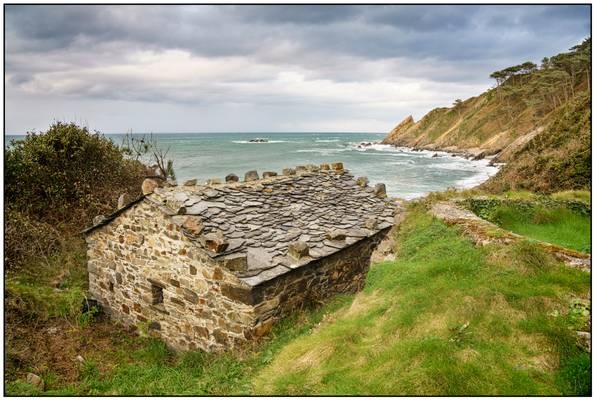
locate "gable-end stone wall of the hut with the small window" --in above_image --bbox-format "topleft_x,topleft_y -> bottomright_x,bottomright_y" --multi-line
87,200 -> 254,351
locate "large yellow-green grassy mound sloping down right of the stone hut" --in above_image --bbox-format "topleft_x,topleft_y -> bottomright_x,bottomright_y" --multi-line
254,209 -> 590,395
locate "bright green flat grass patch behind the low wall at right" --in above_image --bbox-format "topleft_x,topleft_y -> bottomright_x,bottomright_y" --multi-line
490,204 -> 591,253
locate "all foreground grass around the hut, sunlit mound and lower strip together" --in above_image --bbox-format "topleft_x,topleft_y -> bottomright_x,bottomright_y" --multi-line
5,199 -> 591,395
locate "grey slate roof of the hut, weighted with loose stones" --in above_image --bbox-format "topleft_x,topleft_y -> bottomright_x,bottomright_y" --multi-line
86,166 -> 397,286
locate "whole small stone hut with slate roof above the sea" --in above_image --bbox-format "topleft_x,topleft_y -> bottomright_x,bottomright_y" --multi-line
85,163 -> 395,351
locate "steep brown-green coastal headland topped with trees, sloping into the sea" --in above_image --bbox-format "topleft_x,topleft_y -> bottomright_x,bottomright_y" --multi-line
382,38 -> 591,192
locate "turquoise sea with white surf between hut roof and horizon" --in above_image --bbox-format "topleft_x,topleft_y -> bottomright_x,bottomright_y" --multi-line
6,133 -> 497,199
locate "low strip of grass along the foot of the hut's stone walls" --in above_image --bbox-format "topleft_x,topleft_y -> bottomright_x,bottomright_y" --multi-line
5,296 -> 352,396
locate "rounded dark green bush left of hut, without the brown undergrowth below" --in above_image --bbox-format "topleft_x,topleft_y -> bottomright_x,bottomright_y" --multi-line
4,122 -> 146,229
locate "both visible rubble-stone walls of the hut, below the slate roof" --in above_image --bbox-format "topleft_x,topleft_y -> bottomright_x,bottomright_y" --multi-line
87,199 -> 389,351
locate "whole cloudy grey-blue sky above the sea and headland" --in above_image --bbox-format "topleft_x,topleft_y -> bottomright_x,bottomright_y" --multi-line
5,5 -> 590,134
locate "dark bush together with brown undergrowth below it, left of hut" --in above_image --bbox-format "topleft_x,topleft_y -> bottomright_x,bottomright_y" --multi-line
4,122 -> 147,271
